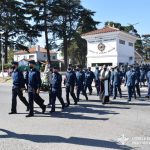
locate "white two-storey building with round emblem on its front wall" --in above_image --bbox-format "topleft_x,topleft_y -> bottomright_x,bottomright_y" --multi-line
82,26 -> 138,67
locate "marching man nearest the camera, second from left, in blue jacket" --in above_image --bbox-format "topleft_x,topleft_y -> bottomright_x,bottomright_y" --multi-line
26,60 -> 46,117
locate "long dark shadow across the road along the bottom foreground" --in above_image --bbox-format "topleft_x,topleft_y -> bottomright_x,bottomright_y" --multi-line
0,129 -> 133,150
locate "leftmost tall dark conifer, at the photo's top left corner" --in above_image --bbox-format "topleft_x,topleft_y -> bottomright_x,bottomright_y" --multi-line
0,0 -> 37,63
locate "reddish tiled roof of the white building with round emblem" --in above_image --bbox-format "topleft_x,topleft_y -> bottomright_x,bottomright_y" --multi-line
82,26 -> 119,36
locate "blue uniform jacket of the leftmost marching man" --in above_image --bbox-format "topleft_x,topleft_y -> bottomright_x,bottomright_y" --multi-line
12,69 -> 24,88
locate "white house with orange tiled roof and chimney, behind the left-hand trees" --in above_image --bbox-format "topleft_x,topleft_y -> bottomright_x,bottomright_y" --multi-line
14,45 -> 59,62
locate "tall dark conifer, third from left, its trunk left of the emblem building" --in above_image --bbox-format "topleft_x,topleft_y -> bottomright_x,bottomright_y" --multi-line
52,0 -> 83,67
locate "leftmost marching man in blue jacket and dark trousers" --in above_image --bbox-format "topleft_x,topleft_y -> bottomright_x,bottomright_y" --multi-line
9,61 -> 29,114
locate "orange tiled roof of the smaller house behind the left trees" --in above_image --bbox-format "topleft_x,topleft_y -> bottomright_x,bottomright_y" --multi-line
15,47 -> 57,55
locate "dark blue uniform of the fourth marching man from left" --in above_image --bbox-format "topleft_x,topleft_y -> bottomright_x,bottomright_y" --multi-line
64,70 -> 77,106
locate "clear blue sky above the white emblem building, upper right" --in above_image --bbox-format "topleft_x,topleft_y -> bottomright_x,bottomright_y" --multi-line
81,0 -> 150,34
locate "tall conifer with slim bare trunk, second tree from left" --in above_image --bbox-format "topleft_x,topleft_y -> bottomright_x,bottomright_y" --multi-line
24,0 -> 57,64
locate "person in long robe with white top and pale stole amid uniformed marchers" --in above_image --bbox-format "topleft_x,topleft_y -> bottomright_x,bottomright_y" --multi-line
100,65 -> 110,104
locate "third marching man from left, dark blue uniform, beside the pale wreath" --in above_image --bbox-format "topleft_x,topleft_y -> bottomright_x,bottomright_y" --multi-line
50,67 -> 65,113
